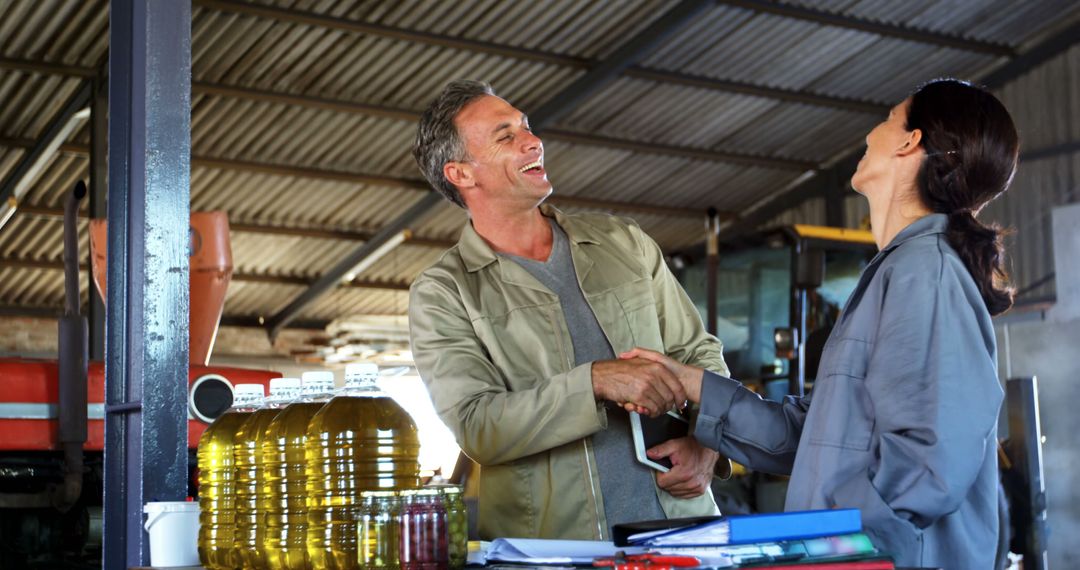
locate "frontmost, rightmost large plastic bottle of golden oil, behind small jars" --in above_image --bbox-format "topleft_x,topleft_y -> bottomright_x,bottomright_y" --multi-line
306,364 -> 420,569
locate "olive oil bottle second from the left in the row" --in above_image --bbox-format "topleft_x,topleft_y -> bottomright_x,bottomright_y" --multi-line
232,378 -> 300,570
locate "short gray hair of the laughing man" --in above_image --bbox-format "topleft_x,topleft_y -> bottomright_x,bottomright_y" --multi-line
413,79 -> 495,207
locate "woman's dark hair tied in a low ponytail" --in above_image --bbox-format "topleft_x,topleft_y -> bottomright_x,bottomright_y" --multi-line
907,79 -> 1020,315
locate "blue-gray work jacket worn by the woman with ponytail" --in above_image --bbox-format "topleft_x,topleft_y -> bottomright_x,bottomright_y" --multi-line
696,214 -> 1002,570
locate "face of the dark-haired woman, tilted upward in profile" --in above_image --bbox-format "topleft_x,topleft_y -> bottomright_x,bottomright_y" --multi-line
851,99 -> 918,195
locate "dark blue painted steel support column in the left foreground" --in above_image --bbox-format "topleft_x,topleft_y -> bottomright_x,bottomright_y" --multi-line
104,0 -> 191,570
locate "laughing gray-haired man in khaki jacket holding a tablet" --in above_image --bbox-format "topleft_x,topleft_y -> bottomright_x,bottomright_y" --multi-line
409,81 -> 727,540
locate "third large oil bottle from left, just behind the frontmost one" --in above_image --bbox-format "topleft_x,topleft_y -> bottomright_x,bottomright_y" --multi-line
262,370 -> 334,570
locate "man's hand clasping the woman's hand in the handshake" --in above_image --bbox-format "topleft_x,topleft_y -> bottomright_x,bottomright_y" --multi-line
593,358 -> 686,417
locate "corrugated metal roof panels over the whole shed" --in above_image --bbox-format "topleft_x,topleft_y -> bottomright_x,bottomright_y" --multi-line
0,0 -> 1080,338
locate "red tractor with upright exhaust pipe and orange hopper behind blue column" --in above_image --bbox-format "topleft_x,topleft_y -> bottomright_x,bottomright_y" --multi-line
0,182 -> 281,568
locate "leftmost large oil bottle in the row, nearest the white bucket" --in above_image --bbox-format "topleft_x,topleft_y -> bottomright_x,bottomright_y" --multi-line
199,384 -> 264,570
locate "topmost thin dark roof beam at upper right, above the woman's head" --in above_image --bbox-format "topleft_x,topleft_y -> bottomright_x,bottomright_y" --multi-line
720,0 -> 1016,57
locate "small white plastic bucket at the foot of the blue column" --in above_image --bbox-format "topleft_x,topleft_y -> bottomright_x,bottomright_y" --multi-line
143,501 -> 199,567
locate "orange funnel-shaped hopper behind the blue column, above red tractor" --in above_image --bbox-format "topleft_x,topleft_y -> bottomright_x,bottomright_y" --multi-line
90,212 -> 232,366
